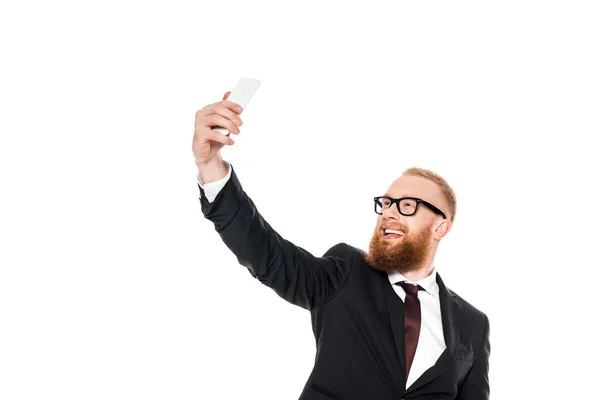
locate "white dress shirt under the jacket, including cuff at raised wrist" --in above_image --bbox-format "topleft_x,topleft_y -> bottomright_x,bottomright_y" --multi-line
198,163 -> 446,388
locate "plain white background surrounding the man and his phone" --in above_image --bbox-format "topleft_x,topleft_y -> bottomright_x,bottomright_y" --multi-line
0,0 -> 600,400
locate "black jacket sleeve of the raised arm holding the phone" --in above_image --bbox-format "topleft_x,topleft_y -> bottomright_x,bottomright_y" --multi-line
198,167 -> 352,310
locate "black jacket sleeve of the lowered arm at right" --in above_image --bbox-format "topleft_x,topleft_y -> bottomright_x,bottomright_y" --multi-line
456,316 -> 490,400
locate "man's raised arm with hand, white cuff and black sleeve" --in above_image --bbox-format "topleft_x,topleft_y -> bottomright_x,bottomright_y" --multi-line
193,91 -> 352,310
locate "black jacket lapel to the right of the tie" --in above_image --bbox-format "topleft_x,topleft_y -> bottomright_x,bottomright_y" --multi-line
402,273 -> 461,394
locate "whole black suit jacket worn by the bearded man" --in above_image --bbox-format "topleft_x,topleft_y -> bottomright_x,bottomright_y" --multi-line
200,164 -> 490,400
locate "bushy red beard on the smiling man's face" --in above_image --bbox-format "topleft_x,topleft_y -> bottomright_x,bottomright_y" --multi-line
365,222 -> 433,274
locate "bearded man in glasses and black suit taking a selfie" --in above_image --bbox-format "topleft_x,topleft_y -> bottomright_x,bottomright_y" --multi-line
192,92 -> 490,400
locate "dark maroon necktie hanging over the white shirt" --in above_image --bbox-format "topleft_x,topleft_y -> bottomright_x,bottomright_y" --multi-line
397,282 -> 423,378
